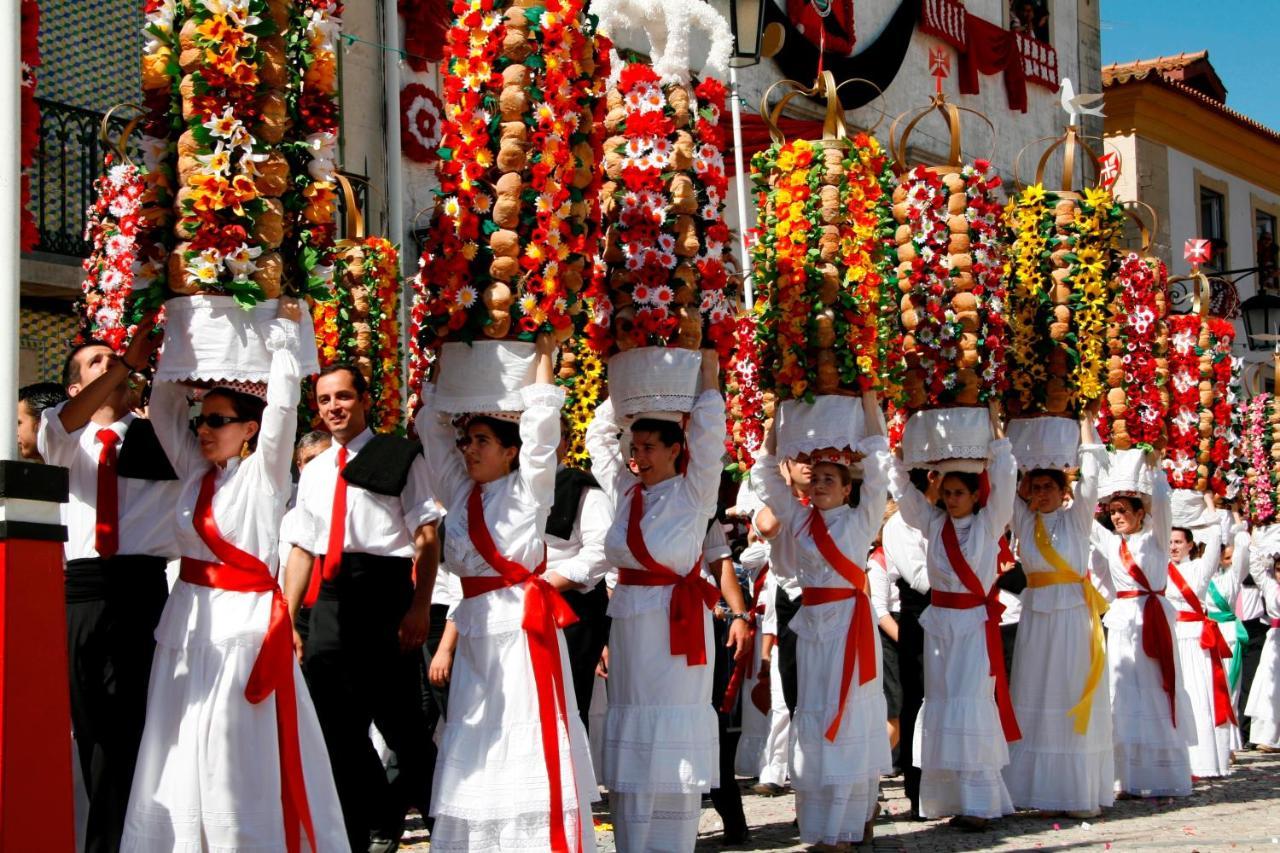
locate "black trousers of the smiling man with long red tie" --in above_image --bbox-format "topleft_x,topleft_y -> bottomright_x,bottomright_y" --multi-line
306,553 -> 431,850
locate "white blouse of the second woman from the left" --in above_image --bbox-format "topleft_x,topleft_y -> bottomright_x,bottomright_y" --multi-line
417,384 -> 564,637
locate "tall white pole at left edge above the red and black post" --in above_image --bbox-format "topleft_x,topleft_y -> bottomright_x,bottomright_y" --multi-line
0,0 -> 22,460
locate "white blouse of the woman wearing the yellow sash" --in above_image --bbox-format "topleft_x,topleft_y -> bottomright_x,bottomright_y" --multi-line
1012,444 -> 1105,612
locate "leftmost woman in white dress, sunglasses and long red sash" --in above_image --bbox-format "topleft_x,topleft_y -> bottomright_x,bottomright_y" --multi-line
120,300 -> 349,853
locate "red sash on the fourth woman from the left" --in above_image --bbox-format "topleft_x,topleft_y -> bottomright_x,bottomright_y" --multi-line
800,507 -> 876,742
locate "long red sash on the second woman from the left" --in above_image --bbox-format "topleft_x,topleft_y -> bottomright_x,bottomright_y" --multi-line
462,483 -> 577,853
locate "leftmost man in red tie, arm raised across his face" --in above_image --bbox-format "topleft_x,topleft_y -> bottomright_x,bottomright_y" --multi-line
36,342 -> 179,853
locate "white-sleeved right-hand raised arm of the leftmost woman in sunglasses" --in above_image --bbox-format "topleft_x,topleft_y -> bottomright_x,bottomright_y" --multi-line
256,311 -> 302,494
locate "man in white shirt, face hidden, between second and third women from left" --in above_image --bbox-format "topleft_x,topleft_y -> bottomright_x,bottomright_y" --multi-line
545,421 -> 613,730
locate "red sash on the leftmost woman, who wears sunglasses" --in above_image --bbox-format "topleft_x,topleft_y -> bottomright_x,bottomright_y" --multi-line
178,467 -> 316,853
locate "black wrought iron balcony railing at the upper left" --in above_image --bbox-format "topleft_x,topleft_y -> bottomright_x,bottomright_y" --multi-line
28,97 -> 137,257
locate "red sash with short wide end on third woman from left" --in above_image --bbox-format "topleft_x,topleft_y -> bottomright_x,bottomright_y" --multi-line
618,483 -> 719,666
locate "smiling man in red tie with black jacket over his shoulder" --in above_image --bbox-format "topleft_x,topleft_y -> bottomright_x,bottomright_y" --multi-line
285,364 -> 440,850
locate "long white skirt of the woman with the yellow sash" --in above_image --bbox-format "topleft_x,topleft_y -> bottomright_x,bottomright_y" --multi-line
1004,605 -> 1115,811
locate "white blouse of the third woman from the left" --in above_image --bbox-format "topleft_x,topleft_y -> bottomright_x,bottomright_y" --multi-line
586,389 -> 724,617
